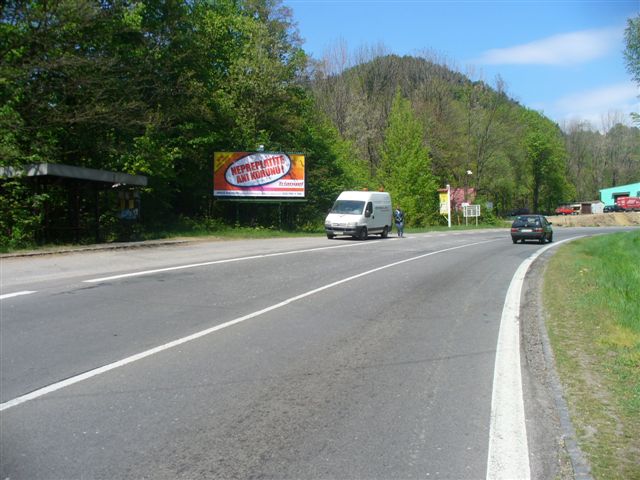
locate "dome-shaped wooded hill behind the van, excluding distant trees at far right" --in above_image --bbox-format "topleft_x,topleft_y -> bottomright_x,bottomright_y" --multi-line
313,55 -> 575,217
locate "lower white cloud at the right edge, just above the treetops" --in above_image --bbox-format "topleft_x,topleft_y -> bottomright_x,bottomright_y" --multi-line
552,82 -> 640,126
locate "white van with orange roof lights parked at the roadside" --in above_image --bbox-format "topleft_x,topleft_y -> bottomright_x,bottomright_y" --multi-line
324,192 -> 393,240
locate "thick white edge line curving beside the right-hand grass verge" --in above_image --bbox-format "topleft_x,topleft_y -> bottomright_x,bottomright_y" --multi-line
487,237 -> 578,480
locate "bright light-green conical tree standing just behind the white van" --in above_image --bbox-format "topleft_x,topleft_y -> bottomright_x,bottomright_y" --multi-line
376,89 -> 438,226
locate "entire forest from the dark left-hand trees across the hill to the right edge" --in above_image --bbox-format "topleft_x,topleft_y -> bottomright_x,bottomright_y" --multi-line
0,0 -> 640,248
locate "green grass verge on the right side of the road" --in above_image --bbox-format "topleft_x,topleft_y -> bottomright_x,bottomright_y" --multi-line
544,231 -> 640,479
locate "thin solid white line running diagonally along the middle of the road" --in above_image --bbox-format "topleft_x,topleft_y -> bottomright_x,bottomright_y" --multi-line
0,239 -> 496,412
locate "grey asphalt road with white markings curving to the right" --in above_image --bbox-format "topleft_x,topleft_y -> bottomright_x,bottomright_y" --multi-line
0,229 -> 632,480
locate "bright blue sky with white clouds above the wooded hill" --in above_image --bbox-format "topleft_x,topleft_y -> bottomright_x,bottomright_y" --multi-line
283,0 -> 640,130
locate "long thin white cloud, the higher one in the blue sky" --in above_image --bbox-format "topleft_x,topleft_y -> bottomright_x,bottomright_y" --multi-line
477,28 -> 623,65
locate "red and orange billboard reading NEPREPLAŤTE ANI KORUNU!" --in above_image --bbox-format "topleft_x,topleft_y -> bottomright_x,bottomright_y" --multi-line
213,152 -> 305,198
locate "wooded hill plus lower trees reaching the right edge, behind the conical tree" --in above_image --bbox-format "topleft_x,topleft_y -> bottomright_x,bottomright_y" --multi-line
313,55 -> 640,214
